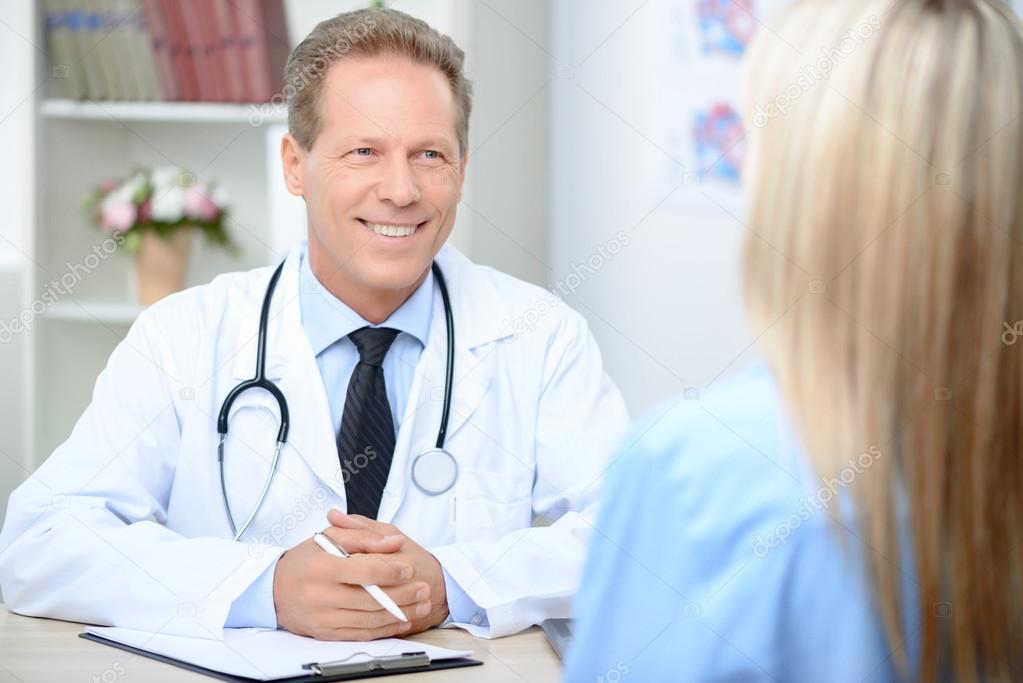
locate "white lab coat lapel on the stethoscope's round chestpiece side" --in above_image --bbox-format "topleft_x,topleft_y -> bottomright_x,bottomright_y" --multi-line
376,246 -> 505,521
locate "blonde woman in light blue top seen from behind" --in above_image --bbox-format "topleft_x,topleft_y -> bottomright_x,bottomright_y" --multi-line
567,0 -> 1023,682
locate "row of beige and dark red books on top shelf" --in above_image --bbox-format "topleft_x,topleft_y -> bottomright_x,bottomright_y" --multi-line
42,0 -> 290,102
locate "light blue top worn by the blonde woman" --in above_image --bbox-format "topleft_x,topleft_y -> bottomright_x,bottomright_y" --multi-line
565,365 -> 919,683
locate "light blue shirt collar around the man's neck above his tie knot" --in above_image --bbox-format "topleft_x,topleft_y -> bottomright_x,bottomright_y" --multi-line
299,242 -> 434,356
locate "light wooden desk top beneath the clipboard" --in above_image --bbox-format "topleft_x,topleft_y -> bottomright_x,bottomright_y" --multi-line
0,604 -> 562,683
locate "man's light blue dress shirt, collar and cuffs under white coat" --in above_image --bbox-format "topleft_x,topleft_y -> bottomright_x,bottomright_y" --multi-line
225,249 -> 486,628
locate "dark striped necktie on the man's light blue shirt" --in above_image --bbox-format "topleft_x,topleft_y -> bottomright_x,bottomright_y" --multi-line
338,327 -> 398,519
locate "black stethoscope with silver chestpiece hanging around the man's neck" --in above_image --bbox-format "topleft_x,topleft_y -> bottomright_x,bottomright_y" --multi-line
217,262 -> 458,541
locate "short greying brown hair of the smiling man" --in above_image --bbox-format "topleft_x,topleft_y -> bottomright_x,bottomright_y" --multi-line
284,7 -> 473,154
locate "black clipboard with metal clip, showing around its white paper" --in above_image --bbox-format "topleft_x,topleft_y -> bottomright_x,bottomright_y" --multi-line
78,633 -> 483,683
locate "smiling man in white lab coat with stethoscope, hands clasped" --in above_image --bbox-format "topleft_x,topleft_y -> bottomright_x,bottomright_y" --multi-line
0,9 -> 628,639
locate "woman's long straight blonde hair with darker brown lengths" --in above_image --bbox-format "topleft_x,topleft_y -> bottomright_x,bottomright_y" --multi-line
744,0 -> 1023,680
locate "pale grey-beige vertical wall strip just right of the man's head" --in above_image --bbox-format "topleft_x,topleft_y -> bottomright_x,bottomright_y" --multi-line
458,0 -> 555,284
